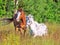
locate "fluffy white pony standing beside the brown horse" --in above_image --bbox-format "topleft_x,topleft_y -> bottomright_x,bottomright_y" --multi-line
27,14 -> 48,37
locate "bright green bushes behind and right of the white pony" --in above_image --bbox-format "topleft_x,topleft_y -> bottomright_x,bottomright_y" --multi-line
23,0 -> 60,23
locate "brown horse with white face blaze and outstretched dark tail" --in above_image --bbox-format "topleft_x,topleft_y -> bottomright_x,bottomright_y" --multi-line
0,9 -> 26,35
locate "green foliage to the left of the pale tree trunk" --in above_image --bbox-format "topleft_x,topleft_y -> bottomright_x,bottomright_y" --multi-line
0,0 -> 14,17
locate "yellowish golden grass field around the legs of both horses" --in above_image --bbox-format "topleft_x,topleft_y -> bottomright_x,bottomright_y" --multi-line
0,23 -> 60,45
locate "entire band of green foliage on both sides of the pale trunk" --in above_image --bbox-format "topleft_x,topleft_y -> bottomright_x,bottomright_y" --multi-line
0,0 -> 60,23
